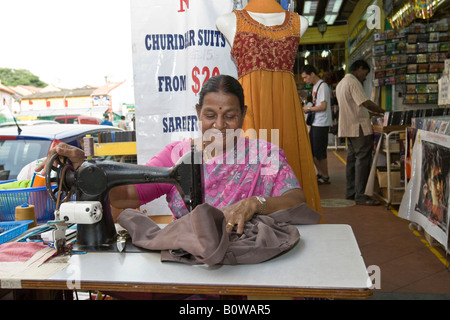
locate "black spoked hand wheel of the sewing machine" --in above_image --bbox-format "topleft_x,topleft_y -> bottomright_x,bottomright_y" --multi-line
45,153 -> 75,203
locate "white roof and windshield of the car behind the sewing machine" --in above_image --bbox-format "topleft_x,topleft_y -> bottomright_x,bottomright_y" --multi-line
0,124 -> 124,180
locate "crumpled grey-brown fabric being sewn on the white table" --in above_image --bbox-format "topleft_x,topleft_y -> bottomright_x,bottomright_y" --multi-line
118,204 -> 321,265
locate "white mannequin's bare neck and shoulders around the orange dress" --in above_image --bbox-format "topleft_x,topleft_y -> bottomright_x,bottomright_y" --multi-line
216,0 -> 308,46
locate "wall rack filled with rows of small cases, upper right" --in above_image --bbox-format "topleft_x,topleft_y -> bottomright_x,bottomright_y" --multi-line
373,22 -> 450,105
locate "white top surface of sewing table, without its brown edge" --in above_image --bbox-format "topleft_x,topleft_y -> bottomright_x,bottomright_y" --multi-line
45,224 -> 372,292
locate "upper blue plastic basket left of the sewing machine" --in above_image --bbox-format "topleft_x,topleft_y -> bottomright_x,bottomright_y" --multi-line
0,182 -> 56,223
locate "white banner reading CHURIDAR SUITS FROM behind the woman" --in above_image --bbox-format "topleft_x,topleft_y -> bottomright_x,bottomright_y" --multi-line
131,0 -> 237,214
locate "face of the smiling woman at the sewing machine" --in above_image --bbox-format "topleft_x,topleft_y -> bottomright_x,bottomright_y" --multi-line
196,91 -> 245,150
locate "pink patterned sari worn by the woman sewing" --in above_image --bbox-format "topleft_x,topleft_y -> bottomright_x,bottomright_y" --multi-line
135,138 -> 300,219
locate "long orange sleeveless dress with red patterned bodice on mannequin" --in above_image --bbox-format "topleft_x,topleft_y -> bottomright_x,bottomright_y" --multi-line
231,10 -> 322,212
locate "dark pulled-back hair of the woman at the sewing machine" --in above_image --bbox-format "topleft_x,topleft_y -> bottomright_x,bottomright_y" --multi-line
198,74 -> 245,112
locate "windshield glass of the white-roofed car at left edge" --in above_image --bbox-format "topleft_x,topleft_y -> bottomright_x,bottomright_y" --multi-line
0,139 -> 51,180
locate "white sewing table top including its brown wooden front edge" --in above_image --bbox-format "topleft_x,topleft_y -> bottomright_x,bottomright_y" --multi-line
14,224 -> 372,299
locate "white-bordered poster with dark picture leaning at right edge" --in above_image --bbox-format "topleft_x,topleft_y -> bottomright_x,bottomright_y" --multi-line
398,130 -> 450,249
